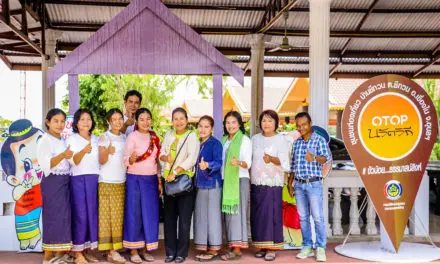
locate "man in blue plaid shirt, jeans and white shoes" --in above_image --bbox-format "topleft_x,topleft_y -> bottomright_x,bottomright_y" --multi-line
287,112 -> 331,261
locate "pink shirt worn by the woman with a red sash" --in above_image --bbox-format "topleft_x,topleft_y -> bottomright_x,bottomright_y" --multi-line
124,131 -> 158,175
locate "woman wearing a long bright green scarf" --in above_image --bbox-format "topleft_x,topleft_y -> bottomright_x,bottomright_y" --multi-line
222,111 -> 252,260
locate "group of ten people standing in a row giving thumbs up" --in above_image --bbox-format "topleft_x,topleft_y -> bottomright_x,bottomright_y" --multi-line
38,90 -> 331,264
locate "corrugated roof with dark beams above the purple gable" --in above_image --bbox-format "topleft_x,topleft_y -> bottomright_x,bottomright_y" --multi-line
0,0 -> 440,78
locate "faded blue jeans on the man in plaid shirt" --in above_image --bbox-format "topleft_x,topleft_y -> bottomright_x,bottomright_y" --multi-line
294,181 -> 327,248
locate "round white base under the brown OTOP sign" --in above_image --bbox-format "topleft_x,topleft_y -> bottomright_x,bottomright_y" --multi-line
335,241 -> 440,263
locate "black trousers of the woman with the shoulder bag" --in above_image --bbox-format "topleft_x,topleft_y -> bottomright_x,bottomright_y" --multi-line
164,191 -> 195,258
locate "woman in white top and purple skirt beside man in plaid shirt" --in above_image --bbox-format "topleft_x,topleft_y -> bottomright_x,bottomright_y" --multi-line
251,110 -> 289,261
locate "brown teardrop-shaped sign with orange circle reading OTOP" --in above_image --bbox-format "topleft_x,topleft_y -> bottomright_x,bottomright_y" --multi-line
342,74 -> 438,252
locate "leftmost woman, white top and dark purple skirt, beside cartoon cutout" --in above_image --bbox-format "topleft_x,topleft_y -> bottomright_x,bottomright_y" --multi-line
38,108 -> 73,264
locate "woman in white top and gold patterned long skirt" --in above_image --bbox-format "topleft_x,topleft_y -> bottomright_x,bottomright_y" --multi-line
98,108 -> 126,264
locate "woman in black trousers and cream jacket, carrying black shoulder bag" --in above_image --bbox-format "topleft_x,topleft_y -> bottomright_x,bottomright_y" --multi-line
160,107 -> 200,263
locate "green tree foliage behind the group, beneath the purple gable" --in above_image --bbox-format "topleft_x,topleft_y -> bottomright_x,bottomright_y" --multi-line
63,74 -> 209,135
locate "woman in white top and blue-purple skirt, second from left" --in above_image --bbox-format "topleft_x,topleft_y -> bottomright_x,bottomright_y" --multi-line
67,109 -> 99,264
